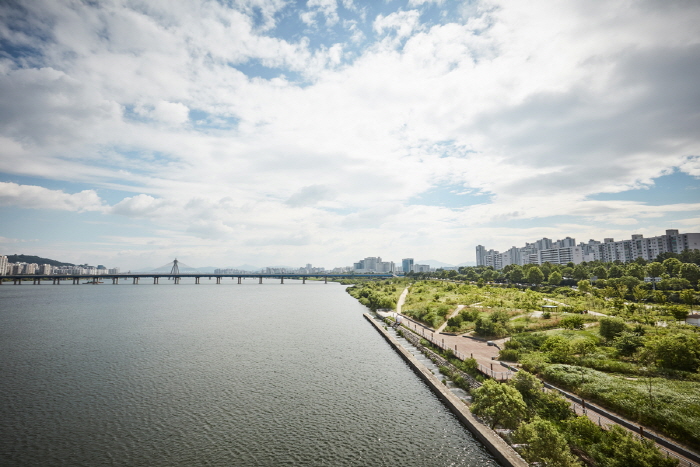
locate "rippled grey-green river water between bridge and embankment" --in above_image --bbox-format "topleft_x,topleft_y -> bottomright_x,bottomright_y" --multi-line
0,279 -> 497,466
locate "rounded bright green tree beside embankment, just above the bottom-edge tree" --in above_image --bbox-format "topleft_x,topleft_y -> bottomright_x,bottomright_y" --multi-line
470,379 -> 527,428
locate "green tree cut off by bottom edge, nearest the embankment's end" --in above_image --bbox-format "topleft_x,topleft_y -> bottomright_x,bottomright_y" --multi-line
513,417 -> 581,467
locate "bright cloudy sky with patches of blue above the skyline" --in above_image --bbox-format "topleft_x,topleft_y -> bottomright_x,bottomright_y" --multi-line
0,0 -> 700,270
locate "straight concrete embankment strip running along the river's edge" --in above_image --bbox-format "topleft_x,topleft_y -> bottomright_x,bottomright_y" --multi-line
364,313 -> 528,467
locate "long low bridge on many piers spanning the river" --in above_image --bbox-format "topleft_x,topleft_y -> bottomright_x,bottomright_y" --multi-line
0,272 -> 397,285
